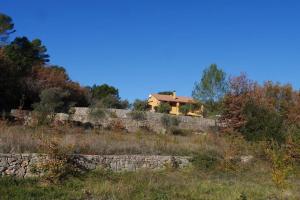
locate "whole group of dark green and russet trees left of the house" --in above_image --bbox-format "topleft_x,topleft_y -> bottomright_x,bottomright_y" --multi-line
0,13 -> 129,112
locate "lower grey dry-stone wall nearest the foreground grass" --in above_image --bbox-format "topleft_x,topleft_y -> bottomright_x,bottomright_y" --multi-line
0,154 -> 190,178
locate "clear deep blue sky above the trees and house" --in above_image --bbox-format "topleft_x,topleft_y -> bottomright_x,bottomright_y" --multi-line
0,0 -> 300,100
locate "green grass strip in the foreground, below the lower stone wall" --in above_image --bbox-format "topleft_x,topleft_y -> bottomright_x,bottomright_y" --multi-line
0,166 -> 300,200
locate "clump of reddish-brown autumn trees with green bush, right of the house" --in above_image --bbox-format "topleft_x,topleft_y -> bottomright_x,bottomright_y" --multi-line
221,74 -> 300,144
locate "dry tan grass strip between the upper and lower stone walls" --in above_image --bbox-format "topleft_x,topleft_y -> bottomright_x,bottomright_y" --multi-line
0,123 -> 224,155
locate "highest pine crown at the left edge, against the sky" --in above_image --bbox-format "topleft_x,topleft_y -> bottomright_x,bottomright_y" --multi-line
0,13 -> 15,47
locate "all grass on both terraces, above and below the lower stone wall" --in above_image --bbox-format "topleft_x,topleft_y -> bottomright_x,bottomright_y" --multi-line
0,123 -> 300,200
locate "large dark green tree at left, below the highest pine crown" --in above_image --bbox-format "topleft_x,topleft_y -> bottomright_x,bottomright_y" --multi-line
0,37 -> 48,110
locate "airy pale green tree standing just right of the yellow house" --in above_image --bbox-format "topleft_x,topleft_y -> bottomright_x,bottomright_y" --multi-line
192,64 -> 227,112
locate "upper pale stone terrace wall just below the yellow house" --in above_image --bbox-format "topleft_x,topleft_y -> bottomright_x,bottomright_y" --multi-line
11,107 -> 216,133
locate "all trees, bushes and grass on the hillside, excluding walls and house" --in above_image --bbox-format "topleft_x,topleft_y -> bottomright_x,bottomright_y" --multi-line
0,11 -> 300,199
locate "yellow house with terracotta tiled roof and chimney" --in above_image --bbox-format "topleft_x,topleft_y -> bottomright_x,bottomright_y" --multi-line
148,92 -> 204,117
